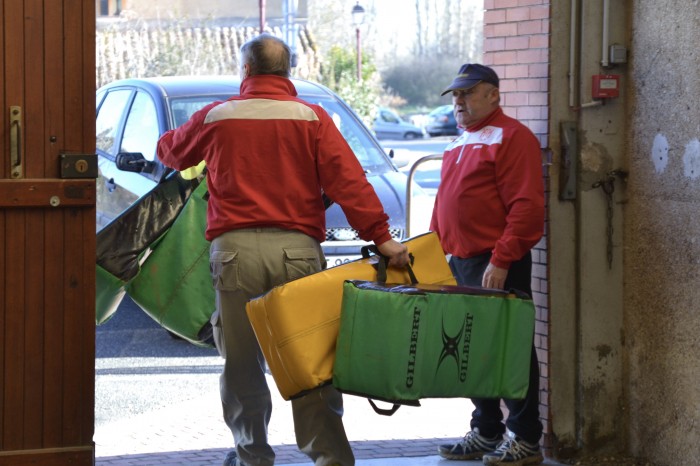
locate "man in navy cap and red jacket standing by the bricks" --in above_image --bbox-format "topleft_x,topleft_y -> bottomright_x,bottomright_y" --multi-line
431,64 -> 544,466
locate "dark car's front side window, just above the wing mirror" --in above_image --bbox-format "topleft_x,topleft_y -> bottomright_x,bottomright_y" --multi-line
119,92 -> 160,161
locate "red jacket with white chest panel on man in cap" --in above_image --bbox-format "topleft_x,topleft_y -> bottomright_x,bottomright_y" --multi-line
431,108 -> 544,269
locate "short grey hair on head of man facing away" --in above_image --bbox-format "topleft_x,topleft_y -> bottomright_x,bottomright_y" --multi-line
241,33 -> 292,78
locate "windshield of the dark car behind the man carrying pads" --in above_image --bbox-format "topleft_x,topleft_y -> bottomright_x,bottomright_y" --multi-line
170,95 -> 392,174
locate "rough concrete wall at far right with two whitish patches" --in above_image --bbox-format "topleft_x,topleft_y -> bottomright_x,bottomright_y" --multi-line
624,0 -> 700,465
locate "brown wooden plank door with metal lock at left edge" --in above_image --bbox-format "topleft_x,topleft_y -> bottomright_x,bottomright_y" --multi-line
0,0 -> 95,466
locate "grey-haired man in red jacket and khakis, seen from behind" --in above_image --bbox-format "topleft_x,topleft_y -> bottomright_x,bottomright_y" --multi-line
158,34 -> 408,466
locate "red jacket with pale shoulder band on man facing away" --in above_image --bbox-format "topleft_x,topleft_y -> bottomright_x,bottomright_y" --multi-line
158,75 -> 391,244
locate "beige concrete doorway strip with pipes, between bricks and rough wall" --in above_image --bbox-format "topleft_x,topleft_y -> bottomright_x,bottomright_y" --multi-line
549,0 -> 628,456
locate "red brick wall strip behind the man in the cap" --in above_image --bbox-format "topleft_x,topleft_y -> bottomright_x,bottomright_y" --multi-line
483,0 -> 552,457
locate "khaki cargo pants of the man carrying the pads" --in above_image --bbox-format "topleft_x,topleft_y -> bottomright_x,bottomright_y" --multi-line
210,228 -> 355,466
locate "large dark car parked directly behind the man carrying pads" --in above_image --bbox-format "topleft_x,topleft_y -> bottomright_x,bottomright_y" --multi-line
96,76 -> 431,266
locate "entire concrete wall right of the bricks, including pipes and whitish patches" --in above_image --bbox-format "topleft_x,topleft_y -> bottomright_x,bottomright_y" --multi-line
548,0 -> 700,466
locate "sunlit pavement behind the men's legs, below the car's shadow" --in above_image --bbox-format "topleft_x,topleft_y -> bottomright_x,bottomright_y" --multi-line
94,340 -> 568,466
